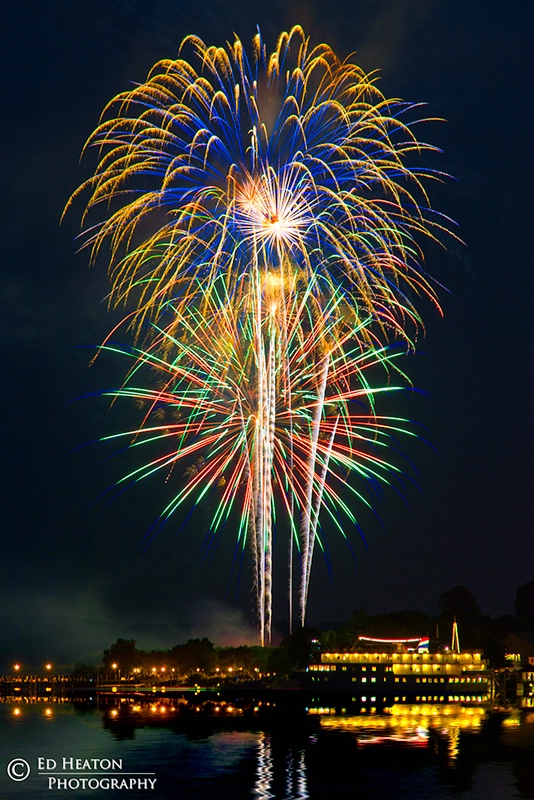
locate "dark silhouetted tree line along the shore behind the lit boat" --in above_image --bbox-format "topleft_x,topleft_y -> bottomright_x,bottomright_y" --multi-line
75,581 -> 534,683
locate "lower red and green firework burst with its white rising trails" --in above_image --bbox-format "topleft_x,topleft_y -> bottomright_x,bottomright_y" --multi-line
97,275 -> 414,644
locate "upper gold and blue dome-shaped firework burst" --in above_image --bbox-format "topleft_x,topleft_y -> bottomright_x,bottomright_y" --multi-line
67,27 -> 452,336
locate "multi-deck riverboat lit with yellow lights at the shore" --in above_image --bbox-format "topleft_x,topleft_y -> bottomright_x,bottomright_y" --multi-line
306,636 -> 492,703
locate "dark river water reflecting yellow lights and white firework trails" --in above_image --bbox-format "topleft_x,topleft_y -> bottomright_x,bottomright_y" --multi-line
0,698 -> 534,800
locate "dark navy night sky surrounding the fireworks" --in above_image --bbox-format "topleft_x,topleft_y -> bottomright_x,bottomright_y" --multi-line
0,0 -> 534,672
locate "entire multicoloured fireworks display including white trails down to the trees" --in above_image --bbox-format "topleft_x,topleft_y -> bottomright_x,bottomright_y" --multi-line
68,27 -> 456,644
